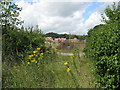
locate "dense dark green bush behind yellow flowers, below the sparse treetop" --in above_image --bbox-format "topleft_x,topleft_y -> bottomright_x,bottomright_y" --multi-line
3,25 -> 45,62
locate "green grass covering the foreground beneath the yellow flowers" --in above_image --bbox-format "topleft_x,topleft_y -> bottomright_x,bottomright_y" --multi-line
3,43 -> 95,88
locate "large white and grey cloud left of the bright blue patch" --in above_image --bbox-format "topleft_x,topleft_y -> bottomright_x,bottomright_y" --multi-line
16,0 -> 90,33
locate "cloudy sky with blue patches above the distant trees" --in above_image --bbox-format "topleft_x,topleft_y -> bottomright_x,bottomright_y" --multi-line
13,0 -> 118,35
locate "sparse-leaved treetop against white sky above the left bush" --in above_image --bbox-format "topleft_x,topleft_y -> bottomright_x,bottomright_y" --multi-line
0,0 -> 22,35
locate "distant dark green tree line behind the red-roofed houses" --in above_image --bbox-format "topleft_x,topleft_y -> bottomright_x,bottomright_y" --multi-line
45,32 -> 87,40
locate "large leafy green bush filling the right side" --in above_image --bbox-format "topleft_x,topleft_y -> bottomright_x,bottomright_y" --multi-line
84,2 -> 120,89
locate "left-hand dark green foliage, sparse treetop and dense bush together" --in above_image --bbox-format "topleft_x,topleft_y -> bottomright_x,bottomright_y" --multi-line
0,2 -> 45,63
